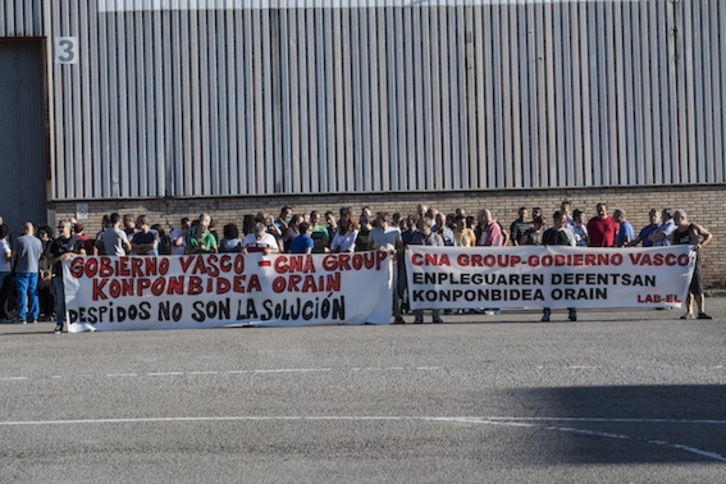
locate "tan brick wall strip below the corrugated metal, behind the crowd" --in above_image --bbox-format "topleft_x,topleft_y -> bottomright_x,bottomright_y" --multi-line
53,185 -> 726,287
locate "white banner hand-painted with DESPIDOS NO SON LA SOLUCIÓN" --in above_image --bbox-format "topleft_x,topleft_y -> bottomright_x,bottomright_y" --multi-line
63,252 -> 392,333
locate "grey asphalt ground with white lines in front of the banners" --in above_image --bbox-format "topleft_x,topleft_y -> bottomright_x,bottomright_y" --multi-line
0,298 -> 726,483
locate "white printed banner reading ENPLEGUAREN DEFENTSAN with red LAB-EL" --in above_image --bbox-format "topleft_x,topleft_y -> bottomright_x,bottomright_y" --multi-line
406,245 -> 696,309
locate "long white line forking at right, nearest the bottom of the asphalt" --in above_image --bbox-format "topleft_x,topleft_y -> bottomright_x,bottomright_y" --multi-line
0,416 -> 726,462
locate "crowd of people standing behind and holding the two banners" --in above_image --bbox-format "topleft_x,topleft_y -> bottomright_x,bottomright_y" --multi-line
0,201 -> 712,332
